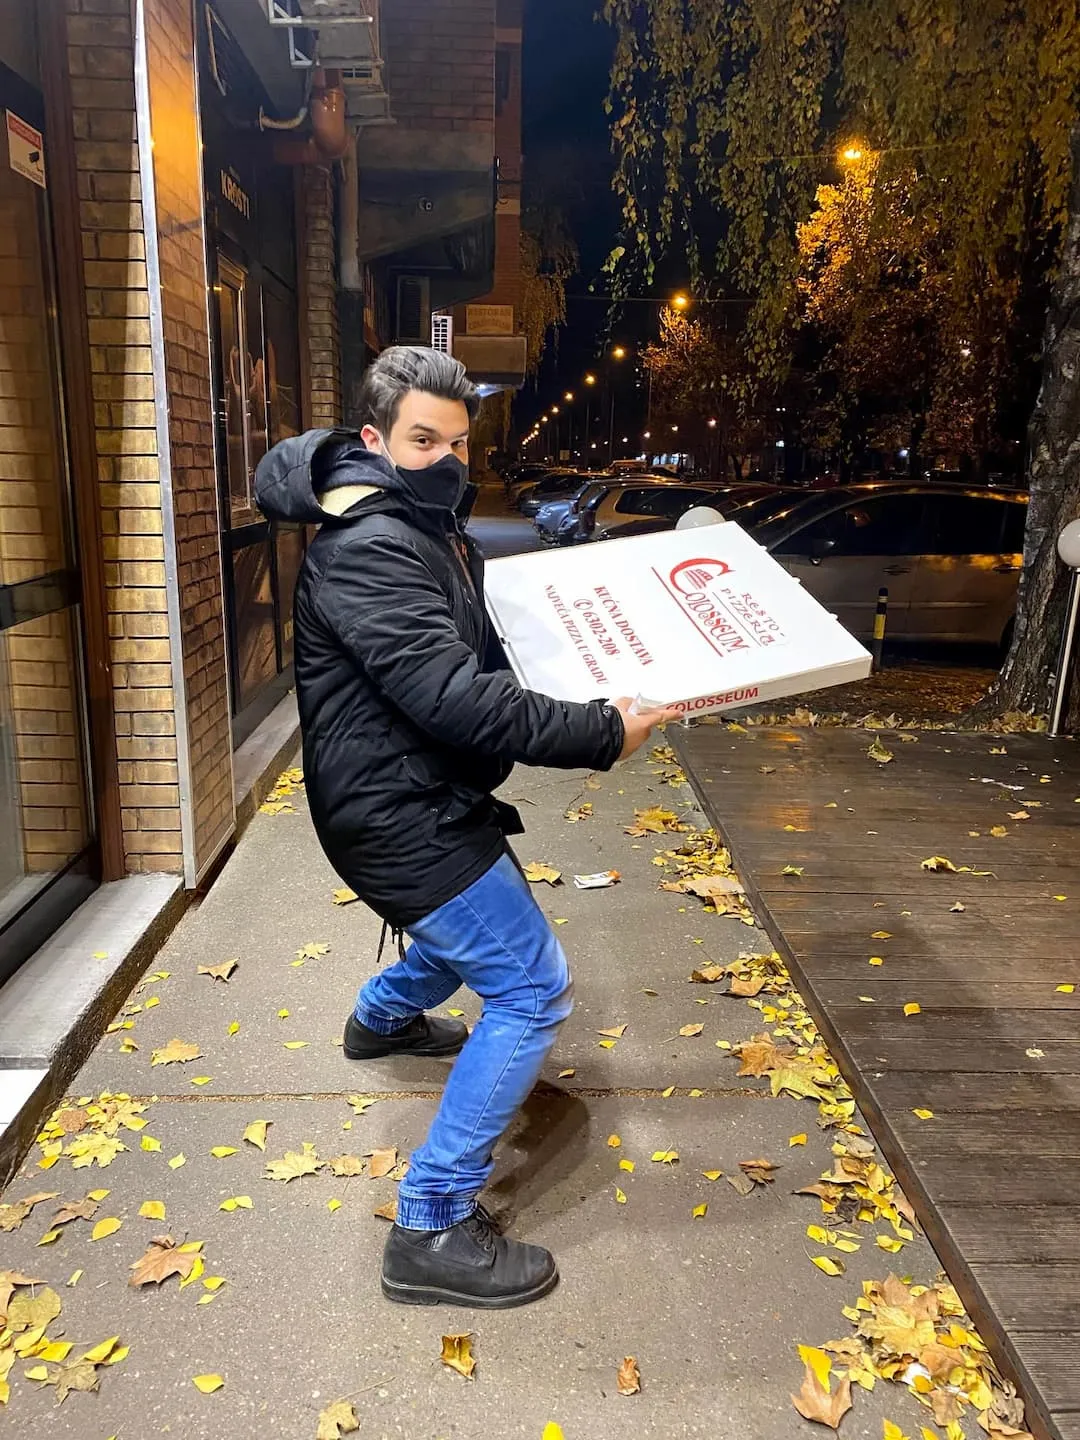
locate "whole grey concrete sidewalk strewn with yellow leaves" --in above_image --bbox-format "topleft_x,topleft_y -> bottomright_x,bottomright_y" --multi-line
0,760 -> 981,1440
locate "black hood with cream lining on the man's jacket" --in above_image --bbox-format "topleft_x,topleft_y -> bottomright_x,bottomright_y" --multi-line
255,429 -> 475,524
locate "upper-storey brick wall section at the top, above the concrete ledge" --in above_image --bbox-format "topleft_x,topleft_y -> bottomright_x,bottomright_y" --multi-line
382,0 -> 495,134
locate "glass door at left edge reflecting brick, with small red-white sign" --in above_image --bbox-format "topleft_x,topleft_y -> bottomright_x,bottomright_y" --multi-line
0,53 -> 98,979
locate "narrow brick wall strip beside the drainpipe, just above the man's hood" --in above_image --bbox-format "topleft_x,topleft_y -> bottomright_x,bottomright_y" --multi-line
298,166 -> 341,428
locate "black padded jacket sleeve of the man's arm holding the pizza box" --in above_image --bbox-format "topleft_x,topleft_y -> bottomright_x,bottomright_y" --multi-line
318,534 -> 624,770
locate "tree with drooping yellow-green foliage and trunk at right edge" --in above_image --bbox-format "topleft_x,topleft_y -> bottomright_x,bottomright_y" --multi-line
605,0 -> 1080,710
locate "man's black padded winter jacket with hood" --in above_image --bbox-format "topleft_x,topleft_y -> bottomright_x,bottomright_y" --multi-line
256,431 -> 624,926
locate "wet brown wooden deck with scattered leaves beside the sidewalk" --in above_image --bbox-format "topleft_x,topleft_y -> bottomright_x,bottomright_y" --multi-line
679,726 -> 1080,1440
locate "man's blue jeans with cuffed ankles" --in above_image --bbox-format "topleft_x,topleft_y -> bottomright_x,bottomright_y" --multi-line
356,855 -> 573,1230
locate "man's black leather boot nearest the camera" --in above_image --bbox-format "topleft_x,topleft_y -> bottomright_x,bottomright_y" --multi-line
383,1205 -> 559,1310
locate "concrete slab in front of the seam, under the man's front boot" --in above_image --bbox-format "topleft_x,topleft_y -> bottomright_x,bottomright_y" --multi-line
0,1092 -> 933,1440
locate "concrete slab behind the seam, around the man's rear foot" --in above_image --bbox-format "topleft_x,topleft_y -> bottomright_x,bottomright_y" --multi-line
82,766 -> 770,1094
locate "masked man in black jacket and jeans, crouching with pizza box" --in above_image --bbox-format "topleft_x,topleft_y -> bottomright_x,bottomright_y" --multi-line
256,347 -> 674,1308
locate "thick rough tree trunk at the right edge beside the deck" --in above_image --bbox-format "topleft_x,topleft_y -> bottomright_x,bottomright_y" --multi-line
972,125 -> 1080,733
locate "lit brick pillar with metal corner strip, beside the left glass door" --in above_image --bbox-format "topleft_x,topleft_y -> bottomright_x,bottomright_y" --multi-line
66,0 -> 232,871
